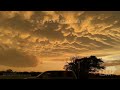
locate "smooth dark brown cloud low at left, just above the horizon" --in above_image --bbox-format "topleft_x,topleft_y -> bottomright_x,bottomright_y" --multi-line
0,49 -> 38,67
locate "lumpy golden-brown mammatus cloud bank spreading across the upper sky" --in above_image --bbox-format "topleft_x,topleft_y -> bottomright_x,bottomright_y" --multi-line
0,11 -> 120,62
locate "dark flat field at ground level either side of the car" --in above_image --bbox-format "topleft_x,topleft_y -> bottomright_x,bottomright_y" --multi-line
0,72 -> 120,79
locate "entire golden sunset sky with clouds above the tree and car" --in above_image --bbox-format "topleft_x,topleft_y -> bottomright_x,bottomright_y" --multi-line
0,11 -> 120,74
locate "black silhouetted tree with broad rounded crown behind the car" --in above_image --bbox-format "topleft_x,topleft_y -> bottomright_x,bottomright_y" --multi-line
64,56 -> 105,78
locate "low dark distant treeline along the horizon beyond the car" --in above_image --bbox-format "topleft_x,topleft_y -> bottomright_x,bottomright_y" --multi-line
0,69 -> 120,79
